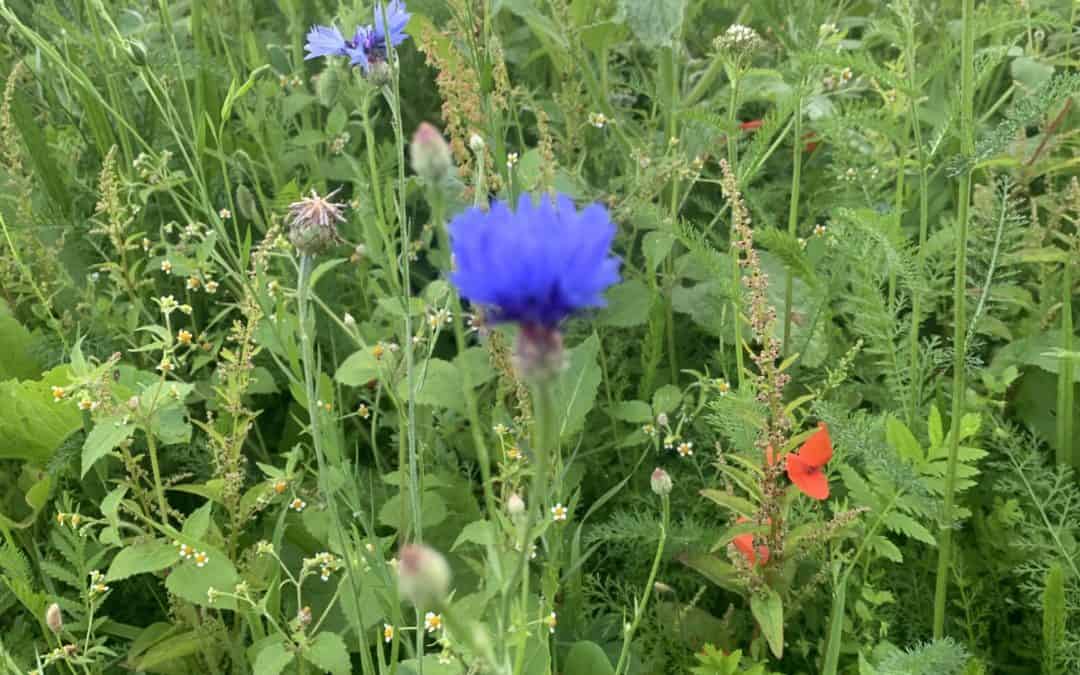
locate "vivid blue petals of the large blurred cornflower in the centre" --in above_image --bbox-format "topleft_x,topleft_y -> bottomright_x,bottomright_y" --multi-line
449,194 -> 620,330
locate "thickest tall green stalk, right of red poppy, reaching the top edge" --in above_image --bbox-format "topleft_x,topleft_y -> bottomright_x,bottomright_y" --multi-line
933,0 -> 975,639
